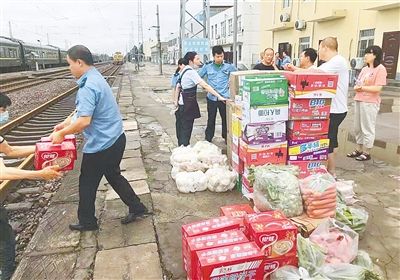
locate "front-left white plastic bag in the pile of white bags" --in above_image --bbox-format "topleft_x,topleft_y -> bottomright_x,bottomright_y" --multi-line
176,171 -> 207,193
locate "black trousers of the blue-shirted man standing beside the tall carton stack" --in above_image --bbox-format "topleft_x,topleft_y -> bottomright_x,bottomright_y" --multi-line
206,98 -> 226,142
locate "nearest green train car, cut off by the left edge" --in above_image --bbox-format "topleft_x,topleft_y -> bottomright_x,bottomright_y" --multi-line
0,36 -> 24,72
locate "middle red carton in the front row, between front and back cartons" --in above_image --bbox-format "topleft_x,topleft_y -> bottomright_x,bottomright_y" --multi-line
185,230 -> 249,279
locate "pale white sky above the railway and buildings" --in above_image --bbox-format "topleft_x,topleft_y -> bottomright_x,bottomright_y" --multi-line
0,0 -> 233,54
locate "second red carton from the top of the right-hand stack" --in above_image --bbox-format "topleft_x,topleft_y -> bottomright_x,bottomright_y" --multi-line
289,98 -> 332,120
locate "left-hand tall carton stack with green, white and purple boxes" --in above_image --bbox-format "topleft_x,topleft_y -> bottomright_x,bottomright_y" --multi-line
228,71 -> 288,194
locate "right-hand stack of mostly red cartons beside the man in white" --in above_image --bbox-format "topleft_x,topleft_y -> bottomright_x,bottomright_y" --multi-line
284,72 -> 337,178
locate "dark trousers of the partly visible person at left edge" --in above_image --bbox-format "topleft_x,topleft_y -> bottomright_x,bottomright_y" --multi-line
0,205 -> 15,280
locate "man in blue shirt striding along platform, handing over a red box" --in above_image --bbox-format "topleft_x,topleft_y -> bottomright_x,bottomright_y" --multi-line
51,45 -> 147,231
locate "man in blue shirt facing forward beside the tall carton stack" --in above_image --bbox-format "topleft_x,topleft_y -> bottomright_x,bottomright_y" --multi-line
199,46 -> 237,142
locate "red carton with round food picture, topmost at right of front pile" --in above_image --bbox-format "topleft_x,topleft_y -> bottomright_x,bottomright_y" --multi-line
249,220 -> 297,258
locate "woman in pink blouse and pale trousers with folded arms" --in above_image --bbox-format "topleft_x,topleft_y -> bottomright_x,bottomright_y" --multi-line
347,46 -> 387,161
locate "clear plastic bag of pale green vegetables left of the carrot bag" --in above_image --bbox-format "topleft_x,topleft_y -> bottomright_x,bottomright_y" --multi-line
253,167 -> 303,218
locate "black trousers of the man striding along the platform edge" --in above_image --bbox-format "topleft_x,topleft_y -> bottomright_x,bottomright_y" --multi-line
78,133 -> 143,225
